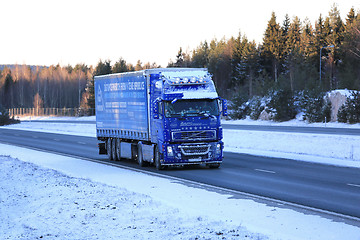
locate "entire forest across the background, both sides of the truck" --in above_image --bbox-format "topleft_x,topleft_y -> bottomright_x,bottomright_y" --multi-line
0,5 -> 360,120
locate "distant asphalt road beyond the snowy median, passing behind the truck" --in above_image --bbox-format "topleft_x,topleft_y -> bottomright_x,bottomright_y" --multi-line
22,120 -> 360,135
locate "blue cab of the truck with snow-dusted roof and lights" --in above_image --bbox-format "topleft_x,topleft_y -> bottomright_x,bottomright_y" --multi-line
151,69 -> 226,168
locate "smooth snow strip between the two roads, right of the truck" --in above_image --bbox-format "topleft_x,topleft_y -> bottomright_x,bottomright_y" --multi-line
223,129 -> 360,168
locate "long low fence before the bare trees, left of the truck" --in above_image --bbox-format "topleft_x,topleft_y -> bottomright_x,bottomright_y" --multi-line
9,108 -> 95,117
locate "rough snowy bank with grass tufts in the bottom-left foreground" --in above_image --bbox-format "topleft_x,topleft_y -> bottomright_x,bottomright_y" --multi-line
0,157 -> 258,239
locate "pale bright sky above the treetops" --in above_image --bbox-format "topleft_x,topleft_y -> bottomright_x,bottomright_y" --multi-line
0,0 -> 360,67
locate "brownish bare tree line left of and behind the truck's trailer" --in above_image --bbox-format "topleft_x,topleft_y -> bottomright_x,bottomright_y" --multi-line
0,58 -> 160,109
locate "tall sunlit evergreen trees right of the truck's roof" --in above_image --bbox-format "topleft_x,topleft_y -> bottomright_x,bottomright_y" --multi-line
169,5 -> 360,98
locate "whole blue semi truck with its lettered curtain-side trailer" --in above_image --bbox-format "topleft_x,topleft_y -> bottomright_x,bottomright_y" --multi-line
94,68 -> 227,170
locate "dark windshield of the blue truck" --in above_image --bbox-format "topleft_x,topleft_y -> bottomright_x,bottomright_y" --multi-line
165,99 -> 219,117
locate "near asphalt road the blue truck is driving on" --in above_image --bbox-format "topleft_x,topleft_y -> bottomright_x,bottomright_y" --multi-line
0,129 -> 360,218
